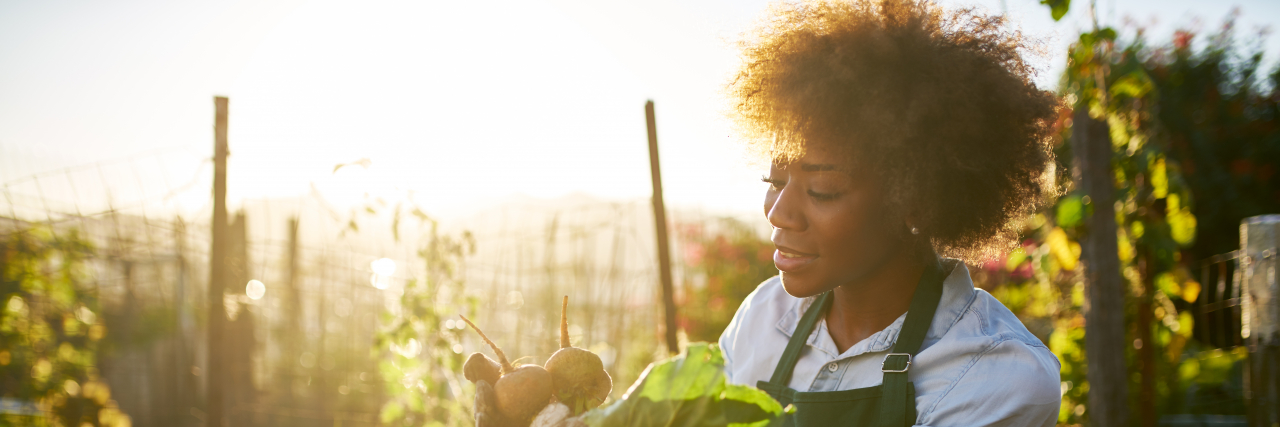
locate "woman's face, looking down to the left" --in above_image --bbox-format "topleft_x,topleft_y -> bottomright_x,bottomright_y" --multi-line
764,150 -> 904,298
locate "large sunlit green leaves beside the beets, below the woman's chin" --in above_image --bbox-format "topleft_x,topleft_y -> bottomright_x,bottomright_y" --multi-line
582,343 -> 782,427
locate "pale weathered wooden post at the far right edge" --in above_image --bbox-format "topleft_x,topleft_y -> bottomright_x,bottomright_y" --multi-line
1235,215 -> 1280,426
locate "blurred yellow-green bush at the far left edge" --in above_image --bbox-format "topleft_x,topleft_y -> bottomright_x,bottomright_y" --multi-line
0,229 -> 131,426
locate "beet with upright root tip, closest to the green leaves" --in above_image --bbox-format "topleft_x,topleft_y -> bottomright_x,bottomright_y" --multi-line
547,295 -> 613,415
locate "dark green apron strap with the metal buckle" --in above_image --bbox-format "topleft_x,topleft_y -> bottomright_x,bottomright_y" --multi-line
875,253 -> 946,427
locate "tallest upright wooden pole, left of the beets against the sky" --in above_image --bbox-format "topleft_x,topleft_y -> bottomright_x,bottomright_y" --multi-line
205,96 -> 228,427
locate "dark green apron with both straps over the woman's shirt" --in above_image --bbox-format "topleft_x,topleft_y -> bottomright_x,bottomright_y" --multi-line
756,256 -> 945,427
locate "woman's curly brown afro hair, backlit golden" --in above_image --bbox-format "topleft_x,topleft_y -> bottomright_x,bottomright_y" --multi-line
727,0 -> 1060,261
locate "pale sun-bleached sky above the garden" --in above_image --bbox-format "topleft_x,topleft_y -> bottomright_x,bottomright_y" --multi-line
0,0 -> 1280,216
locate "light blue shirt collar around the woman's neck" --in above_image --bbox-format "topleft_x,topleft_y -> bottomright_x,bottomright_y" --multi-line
776,258 -> 975,358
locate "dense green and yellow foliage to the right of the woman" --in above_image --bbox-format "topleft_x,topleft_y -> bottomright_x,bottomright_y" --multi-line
1029,9 -> 1280,424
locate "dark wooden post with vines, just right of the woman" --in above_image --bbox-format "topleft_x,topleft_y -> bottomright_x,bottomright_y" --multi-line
1071,106 -> 1129,427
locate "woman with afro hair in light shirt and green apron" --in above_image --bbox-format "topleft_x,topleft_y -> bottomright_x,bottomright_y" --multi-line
719,0 -> 1061,427
